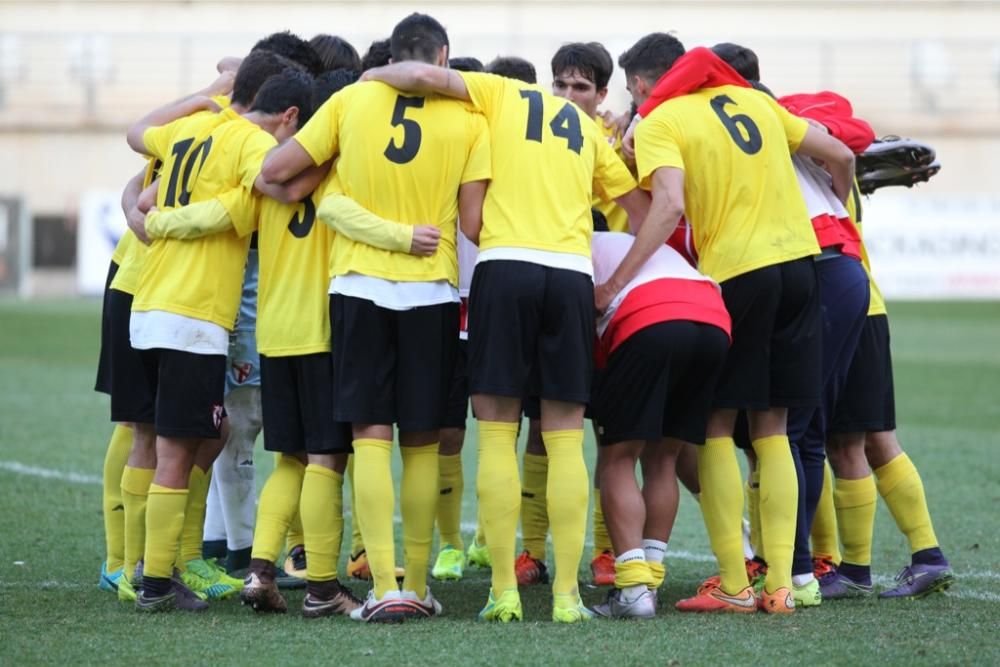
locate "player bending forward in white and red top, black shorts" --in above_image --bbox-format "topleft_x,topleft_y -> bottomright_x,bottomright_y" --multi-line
592,232 -> 730,618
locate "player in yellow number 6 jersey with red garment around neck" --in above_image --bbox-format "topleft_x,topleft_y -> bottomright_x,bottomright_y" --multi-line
620,33 -> 853,613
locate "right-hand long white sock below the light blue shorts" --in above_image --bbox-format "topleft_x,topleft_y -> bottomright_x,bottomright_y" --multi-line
212,387 -> 263,551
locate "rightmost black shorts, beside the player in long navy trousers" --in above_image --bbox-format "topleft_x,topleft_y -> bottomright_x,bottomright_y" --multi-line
827,315 -> 896,433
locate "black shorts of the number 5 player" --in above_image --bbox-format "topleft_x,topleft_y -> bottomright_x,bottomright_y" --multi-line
330,294 -> 459,431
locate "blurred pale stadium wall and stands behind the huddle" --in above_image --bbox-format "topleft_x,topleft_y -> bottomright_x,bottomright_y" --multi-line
0,0 -> 1000,299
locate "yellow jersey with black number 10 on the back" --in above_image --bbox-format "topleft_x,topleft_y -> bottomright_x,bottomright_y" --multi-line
132,109 -> 277,329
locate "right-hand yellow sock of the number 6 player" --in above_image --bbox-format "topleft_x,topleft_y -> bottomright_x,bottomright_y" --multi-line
752,435 -> 799,593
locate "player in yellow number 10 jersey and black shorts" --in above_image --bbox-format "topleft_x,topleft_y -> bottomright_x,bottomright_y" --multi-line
128,62 -> 311,611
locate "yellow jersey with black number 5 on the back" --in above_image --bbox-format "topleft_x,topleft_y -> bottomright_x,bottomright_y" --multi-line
294,81 -> 491,286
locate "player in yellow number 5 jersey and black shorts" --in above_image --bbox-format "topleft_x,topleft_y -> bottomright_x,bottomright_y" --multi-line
263,14 -> 490,621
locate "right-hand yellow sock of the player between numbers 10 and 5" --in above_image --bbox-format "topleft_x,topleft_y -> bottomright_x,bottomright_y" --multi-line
299,464 -> 344,581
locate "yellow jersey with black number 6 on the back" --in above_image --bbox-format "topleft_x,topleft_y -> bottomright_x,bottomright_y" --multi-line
635,85 -> 819,283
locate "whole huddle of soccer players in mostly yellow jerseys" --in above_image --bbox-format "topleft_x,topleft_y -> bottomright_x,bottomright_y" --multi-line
97,14 -> 953,623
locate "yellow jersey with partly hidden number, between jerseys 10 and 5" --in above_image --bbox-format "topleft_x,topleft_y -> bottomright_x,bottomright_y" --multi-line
257,169 -> 336,357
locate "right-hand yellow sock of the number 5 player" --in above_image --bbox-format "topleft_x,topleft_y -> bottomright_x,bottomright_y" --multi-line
399,442 -> 441,600
